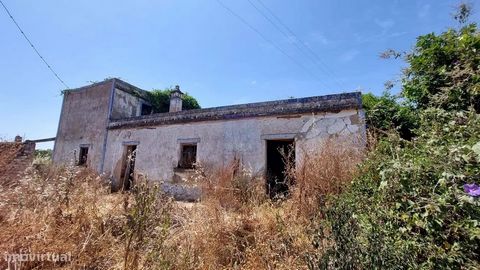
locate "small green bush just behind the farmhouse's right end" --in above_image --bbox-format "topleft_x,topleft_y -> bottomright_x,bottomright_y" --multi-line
362,92 -> 417,140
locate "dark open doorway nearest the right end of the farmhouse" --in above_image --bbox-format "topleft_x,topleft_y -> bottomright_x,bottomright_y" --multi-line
266,139 -> 295,199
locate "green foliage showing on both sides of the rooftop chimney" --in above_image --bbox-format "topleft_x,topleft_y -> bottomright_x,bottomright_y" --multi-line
148,88 -> 200,113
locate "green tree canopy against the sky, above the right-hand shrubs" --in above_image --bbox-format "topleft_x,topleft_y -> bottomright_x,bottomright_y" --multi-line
362,7 -> 480,140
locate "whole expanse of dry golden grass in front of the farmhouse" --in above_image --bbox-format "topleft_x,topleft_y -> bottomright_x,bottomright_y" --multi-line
0,141 -> 362,269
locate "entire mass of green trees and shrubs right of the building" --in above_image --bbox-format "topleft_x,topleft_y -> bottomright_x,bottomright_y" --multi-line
309,6 -> 480,269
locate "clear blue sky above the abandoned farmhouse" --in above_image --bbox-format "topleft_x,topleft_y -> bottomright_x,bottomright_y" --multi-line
0,0 -> 479,148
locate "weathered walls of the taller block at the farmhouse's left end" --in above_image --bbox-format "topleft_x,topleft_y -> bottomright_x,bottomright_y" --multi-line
53,79 -> 151,173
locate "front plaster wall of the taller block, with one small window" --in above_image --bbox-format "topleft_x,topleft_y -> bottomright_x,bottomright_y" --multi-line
53,82 -> 113,171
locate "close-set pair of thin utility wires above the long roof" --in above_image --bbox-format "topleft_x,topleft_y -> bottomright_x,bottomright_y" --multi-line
253,0 -> 345,87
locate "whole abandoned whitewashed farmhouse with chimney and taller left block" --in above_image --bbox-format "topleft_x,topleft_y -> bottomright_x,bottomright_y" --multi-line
53,79 -> 365,197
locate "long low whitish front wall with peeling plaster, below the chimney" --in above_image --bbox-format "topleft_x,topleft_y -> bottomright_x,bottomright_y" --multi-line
104,110 -> 365,187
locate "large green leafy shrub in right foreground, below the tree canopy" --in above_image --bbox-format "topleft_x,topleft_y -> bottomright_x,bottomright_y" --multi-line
317,109 -> 480,269
